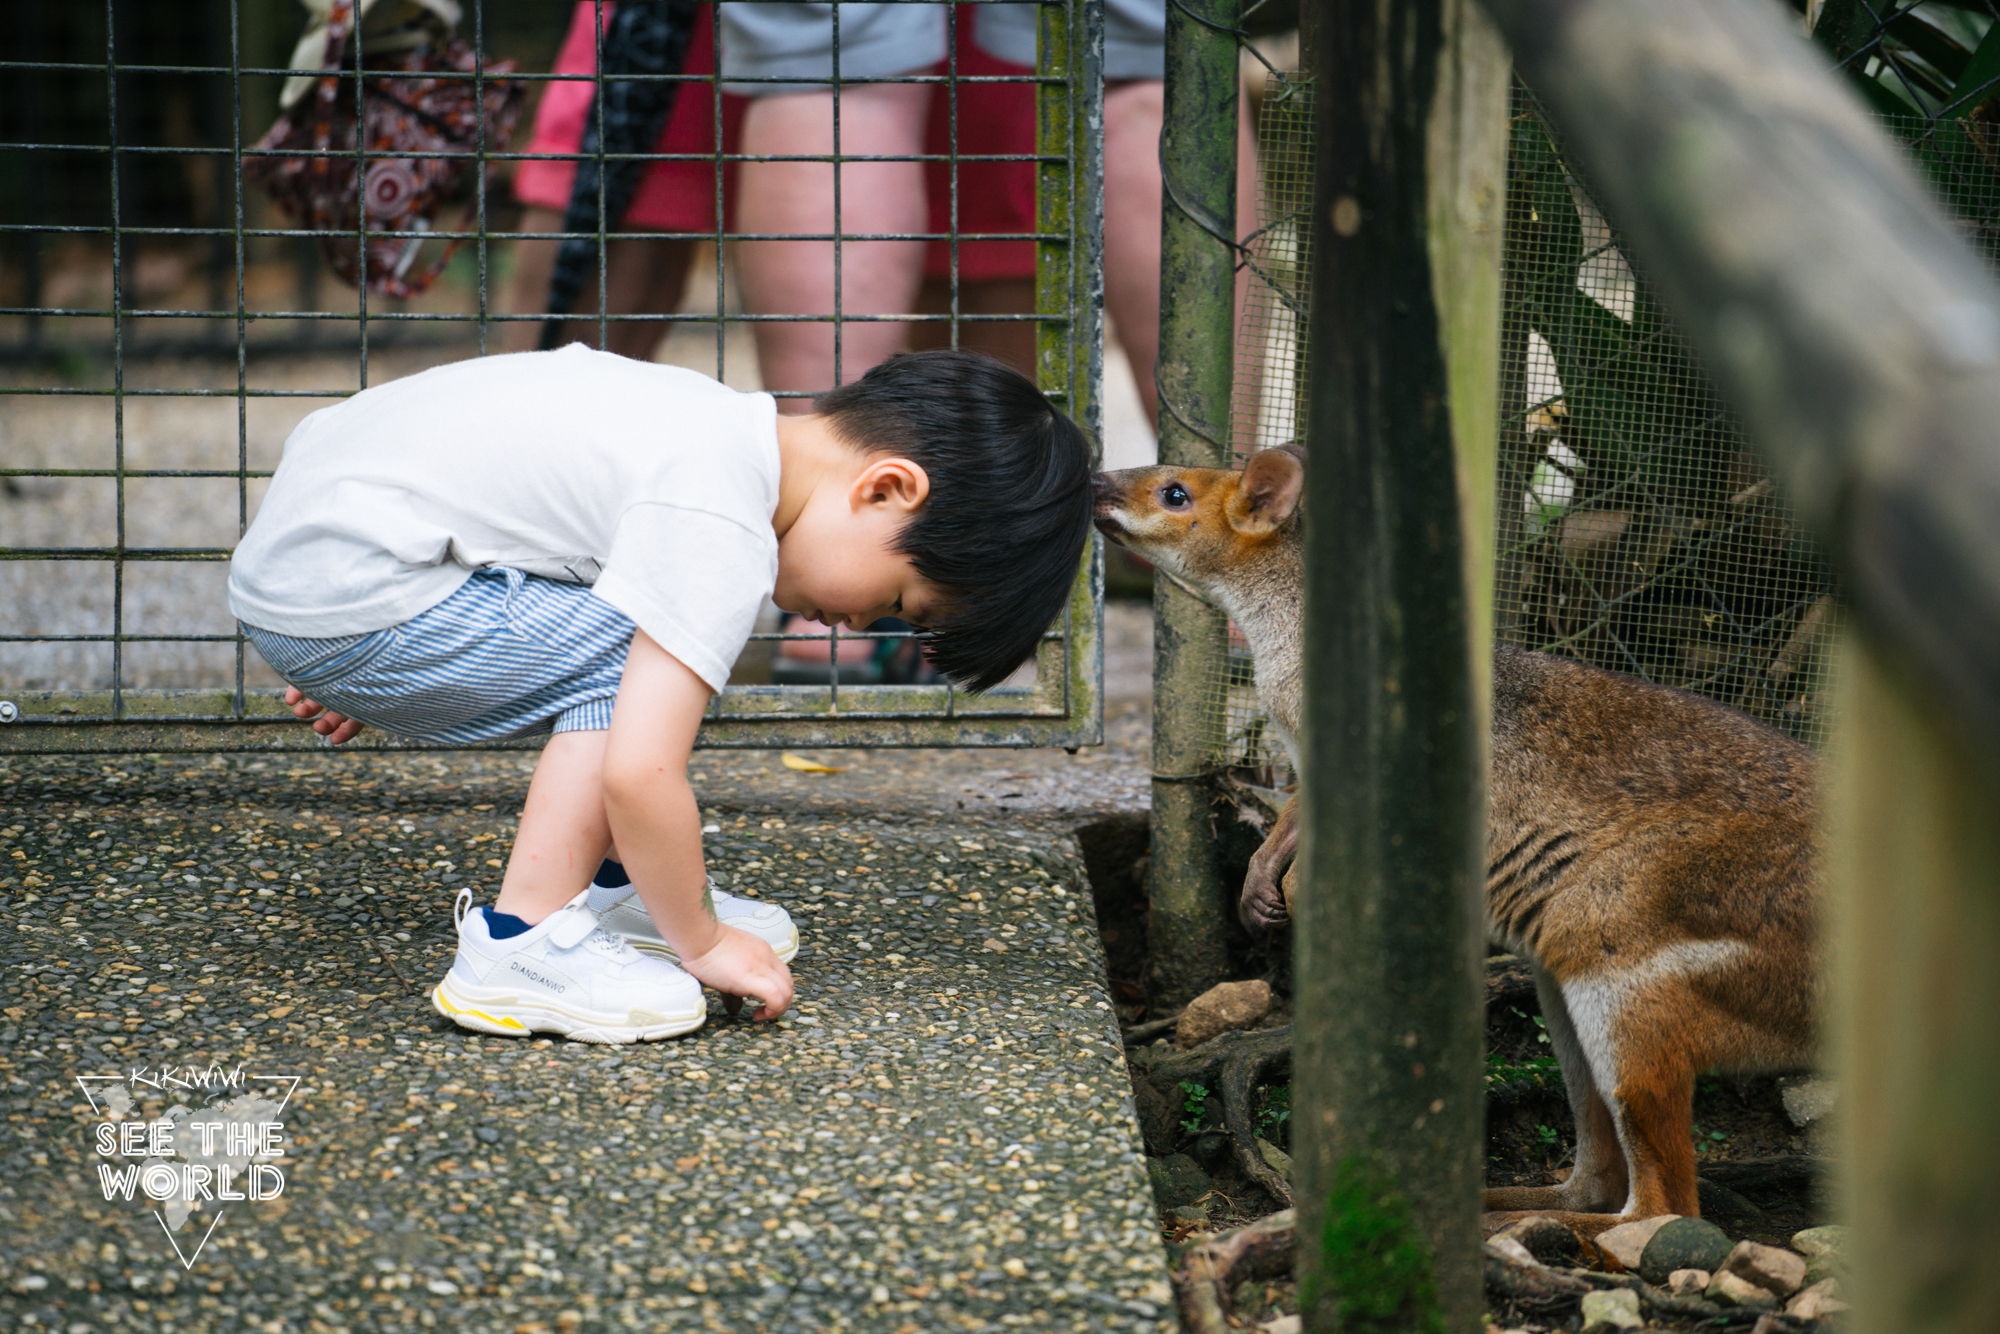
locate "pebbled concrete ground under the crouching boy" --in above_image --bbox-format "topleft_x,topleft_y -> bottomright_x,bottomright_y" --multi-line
0,684 -> 1174,1334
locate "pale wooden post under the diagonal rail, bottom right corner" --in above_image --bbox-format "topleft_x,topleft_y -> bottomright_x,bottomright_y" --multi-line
1828,642 -> 2000,1334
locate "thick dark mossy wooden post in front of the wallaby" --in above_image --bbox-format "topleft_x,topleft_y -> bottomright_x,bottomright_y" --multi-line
1292,0 -> 1508,1334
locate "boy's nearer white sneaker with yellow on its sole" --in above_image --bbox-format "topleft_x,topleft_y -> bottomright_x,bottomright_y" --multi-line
430,888 -> 708,1042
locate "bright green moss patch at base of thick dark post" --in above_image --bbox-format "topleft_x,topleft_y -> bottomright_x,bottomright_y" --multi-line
1304,1154 -> 1444,1334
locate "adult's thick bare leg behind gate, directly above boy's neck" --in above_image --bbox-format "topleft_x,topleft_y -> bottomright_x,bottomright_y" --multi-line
736,84 -> 930,412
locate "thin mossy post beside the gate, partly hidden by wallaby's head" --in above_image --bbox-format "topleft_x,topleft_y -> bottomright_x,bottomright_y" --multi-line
1146,0 -> 1238,1000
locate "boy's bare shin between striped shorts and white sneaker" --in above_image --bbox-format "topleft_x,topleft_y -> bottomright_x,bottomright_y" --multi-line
494,732 -> 612,926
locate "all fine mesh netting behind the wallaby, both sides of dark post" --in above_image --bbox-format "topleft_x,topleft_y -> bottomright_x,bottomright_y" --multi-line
1204,76 -> 2000,772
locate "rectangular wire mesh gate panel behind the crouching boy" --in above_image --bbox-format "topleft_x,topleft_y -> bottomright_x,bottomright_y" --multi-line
0,0 -> 1102,750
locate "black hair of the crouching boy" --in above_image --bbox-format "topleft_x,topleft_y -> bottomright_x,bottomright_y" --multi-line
812,350 -> 1094,690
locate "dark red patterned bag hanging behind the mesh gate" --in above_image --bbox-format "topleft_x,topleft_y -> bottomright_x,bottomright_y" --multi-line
244,0 -> 522,296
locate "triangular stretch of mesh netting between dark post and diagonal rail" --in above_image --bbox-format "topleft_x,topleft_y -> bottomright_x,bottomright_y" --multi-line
1496,88 -> 1836,740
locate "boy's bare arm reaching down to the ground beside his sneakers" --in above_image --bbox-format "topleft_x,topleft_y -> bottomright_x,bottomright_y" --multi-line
604,630 -> 792,1018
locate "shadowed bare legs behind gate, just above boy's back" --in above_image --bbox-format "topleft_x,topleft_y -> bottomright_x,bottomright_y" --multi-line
496,208 -> 694,362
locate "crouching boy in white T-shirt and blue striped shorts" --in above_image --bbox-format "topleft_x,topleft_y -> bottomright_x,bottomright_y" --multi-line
230,344 -> 1092,1042
